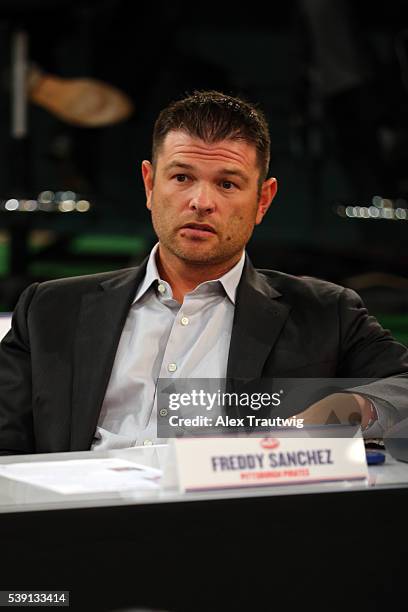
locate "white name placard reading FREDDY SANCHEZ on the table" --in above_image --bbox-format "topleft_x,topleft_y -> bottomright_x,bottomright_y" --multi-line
174,437 -> 368,491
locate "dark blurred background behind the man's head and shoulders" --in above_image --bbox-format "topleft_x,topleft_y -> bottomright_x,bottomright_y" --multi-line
0,0 -> 408,340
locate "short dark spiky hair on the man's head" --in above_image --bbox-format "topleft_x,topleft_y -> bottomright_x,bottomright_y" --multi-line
152,91 -> 270,185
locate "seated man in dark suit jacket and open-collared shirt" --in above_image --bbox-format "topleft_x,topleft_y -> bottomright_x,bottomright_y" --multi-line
0,92 -> 408,453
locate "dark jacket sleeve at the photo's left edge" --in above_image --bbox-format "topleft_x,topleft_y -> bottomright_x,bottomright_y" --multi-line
0,283 -> 38,455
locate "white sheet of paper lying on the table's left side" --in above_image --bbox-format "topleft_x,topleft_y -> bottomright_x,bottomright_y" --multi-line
0,458 -> 162,494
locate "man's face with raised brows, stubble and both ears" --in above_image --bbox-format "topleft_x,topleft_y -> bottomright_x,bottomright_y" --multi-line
142,131 -> 276,265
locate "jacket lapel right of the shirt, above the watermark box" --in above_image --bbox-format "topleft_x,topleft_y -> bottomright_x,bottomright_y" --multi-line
227,258 -> 290,381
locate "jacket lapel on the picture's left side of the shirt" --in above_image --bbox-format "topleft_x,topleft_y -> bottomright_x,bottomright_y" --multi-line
71,260 -> 147,451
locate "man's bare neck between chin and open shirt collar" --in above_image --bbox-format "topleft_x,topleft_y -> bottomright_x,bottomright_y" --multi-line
156,245 -> 242,304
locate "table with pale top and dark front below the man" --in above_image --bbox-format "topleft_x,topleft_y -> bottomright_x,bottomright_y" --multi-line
0,445 -> 408,612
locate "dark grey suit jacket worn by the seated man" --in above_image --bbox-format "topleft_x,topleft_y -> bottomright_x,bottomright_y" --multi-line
0,259 -> 408,453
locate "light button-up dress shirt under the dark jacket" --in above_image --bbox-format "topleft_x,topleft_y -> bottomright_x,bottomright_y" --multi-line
92,245 -> 245,450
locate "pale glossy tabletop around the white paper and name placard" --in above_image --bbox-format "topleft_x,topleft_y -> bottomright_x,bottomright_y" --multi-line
0,445 -> 408,513
